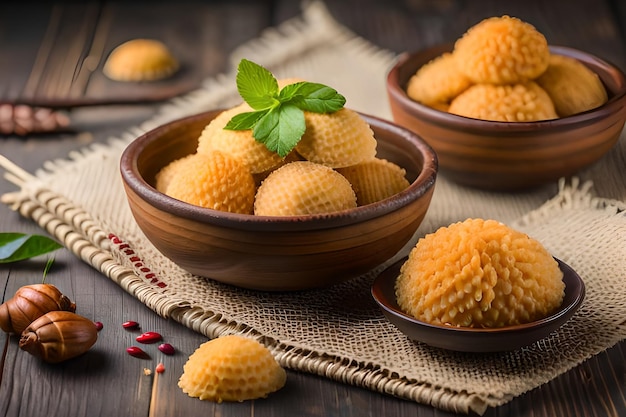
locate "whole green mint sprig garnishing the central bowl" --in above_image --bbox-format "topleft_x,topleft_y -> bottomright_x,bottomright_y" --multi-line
224,59 -> 346,157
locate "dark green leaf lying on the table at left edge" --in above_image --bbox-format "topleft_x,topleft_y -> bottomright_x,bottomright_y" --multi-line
0,233 -> 63,263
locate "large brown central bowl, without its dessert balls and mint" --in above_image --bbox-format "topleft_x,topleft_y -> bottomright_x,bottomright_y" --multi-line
120,110 -> 437,291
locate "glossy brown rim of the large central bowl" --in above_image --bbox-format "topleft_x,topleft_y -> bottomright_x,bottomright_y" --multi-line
120,109 -> 438,231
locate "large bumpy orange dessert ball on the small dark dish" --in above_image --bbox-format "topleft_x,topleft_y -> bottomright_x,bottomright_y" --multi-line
395,219 -> 565,328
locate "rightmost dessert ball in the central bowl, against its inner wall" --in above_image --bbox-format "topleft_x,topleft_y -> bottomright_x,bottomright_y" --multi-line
337,158 -> 409,206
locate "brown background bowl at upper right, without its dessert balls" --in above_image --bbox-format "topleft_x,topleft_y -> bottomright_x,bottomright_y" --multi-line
387,45 -> 626,191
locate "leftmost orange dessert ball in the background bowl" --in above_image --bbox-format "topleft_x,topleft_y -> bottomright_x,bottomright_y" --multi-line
407,53 -> 472,109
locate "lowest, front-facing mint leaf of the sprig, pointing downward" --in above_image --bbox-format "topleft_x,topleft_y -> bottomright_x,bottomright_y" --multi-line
252,103 -> 306,158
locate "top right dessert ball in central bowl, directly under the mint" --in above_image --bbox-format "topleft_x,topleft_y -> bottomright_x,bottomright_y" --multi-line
296,107 -> 376,168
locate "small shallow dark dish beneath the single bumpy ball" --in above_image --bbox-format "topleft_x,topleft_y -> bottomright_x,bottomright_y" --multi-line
372,258 -> 585,353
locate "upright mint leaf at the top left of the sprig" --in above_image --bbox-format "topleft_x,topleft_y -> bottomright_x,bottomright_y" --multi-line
236,59 -> 278,110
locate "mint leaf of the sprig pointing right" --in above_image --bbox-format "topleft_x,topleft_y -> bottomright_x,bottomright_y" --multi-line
278,81 -> 346,113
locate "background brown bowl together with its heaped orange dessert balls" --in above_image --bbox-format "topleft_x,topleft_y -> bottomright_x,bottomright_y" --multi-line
387,16 -> 626,191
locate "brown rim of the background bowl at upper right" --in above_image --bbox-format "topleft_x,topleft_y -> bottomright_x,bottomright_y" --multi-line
387,43 -> 626,133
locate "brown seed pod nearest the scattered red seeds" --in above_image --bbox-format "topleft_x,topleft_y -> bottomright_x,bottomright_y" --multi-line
19,311 -> 98,363
